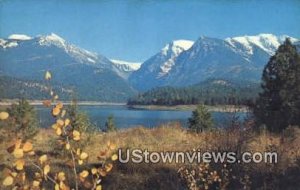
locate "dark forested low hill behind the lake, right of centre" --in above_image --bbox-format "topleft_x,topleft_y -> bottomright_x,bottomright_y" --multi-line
128,79 -> 260,105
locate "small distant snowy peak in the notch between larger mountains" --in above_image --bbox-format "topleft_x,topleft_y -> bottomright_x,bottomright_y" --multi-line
110,59 -> 141,79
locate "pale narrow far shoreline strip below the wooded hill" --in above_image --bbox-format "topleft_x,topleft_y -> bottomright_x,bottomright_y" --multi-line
128,105 -> 249,112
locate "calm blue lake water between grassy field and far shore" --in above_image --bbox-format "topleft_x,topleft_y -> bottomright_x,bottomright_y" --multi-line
36,106 -> 247,128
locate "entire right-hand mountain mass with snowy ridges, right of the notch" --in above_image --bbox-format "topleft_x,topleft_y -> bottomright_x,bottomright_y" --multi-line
129,34 -> 298,91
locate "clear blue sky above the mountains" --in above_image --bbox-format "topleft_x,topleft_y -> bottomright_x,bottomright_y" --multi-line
0,0 -> 300,62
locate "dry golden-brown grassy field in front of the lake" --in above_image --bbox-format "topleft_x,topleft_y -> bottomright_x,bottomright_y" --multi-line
0,123 -> 300,190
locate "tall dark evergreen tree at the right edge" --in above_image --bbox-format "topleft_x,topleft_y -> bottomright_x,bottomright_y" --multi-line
254,39 -> 300,132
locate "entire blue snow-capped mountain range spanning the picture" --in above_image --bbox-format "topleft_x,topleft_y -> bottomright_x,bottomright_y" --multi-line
0,34 -> 300,102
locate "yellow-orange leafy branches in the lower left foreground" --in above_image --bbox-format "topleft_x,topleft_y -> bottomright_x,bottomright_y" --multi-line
0,71 -> 118,190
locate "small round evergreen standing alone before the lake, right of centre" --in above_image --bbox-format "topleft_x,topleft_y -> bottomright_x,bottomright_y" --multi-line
188,105 -> 213,133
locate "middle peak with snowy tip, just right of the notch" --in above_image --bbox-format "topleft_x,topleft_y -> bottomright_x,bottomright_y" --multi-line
129,40 -> 194,90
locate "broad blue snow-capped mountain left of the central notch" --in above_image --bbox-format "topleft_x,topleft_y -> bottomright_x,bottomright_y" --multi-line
0,34 -> 135,101
